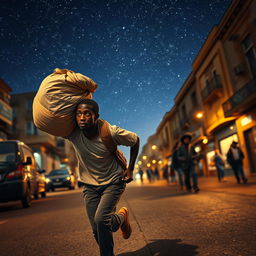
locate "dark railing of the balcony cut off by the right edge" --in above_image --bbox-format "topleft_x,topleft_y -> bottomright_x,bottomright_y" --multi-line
222,79 -> 256,116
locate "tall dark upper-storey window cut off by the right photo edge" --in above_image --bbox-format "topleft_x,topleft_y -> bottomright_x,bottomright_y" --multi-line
242,35 -> 256,78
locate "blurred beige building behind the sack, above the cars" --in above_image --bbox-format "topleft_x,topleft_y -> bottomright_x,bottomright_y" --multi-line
11,92 -> 76,173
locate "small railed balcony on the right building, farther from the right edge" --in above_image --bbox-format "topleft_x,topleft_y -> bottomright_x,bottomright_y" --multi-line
202,75 -> 223,103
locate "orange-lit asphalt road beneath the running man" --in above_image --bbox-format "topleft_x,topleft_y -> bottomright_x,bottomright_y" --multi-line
0,184 -> 256,256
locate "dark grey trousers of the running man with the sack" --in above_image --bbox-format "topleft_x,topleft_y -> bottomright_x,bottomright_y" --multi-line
84,181 -> 126,256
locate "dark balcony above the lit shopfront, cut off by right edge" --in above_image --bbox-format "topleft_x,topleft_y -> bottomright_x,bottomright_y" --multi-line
222,79 -> 256,117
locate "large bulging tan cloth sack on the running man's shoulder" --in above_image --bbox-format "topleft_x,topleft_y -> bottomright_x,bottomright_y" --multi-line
33,69 -> 97,137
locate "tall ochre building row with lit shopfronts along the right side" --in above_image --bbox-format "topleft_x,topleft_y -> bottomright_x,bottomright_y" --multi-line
140,0 -> 256,175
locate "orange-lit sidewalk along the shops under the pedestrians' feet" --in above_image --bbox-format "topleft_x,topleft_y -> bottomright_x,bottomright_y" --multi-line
133,176 -> 256,196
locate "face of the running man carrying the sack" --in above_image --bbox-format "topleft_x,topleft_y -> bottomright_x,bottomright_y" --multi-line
76,104 -> 97,129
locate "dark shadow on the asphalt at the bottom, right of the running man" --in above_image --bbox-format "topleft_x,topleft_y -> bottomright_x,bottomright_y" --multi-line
118,239 -> 198,256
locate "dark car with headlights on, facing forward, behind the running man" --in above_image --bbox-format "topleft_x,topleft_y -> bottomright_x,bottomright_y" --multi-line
46,169 -> 75,191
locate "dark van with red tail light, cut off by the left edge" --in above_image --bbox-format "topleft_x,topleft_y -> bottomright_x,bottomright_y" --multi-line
0,140 -> 46,207
